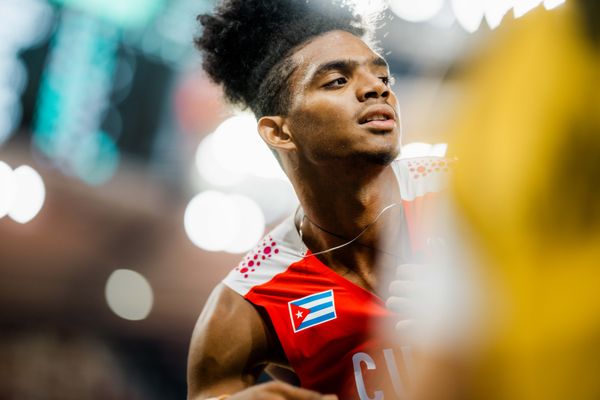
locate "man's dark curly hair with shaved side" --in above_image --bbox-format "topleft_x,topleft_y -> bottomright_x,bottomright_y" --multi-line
195,0 -> 373,118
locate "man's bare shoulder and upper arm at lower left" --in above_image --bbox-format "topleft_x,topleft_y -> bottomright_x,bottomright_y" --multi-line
188,284 -> 270,399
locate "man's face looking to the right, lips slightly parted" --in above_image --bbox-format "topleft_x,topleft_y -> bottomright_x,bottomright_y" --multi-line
287,31 -> 401,165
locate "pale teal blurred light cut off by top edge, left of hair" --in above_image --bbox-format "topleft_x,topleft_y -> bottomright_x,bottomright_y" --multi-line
53,0 -> 166,28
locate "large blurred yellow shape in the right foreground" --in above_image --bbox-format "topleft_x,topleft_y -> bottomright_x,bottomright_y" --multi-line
454,0 -> 600,400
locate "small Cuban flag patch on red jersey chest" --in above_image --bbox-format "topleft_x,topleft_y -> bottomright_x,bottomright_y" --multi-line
288,289 -> 337,333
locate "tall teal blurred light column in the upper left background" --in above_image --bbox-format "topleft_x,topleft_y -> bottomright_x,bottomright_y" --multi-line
33,10 -> 121,185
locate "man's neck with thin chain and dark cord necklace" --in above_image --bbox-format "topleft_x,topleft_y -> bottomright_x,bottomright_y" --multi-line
292,159 -> 402,290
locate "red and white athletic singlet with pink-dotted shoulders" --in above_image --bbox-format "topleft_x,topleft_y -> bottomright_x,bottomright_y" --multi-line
223,157 -> 452,400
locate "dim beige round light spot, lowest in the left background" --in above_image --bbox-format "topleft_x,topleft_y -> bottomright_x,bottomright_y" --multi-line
105,269 -> 154,321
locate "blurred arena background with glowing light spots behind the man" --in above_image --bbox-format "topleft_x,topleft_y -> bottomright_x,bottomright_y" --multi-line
0,0 -> 576,399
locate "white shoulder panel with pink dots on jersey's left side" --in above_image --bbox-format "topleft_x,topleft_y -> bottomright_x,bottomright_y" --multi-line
223,216 -> 305,296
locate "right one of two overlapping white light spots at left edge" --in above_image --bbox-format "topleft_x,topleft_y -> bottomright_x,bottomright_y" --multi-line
8,165 -> 46,224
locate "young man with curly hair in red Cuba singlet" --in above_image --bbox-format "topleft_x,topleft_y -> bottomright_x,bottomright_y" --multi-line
188,0 -> 446,400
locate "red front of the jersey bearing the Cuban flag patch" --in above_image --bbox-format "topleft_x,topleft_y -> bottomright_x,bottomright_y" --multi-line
250,262 -> 405,399
